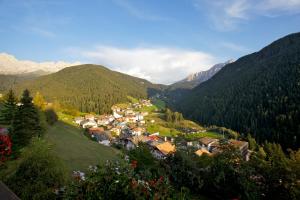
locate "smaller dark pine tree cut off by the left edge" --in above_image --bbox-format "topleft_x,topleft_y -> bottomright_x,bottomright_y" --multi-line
0,90 -> 17,125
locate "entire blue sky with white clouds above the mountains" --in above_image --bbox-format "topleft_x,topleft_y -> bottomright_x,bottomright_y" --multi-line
0,0 -> 300,84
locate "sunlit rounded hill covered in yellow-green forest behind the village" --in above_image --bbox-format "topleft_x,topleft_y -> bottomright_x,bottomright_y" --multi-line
15,65 -> 164,113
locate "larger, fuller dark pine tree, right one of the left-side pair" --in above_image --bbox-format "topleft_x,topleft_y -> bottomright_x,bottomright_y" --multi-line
12,90 -> 42,148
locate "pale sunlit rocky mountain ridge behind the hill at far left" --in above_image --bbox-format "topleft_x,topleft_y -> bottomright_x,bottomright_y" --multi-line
0,53 -> 80,74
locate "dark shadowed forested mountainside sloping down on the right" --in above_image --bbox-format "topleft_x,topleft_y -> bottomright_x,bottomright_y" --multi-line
176,33 -> 300,147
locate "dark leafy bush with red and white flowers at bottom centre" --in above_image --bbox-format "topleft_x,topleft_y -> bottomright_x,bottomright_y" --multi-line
66,159 -> 184,200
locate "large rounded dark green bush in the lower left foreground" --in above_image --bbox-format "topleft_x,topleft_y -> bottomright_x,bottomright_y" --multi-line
7,139 -> 67,200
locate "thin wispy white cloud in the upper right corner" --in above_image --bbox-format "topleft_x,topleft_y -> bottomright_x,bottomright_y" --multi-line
194,0 -> 300,31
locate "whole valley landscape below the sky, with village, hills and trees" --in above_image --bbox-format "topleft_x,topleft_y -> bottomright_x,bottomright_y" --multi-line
0,33 -> 300,199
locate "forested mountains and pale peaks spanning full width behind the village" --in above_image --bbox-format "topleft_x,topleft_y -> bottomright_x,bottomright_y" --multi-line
0,33 -> 300,147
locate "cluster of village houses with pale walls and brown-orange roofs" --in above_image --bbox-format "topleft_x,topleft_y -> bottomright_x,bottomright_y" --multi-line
74,100 -> 250,160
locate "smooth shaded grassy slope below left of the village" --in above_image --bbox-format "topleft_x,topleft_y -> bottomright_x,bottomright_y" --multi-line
45,121 -> 119,171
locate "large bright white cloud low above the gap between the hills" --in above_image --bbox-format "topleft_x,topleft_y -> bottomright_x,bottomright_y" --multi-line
68,46 -> 217,84
